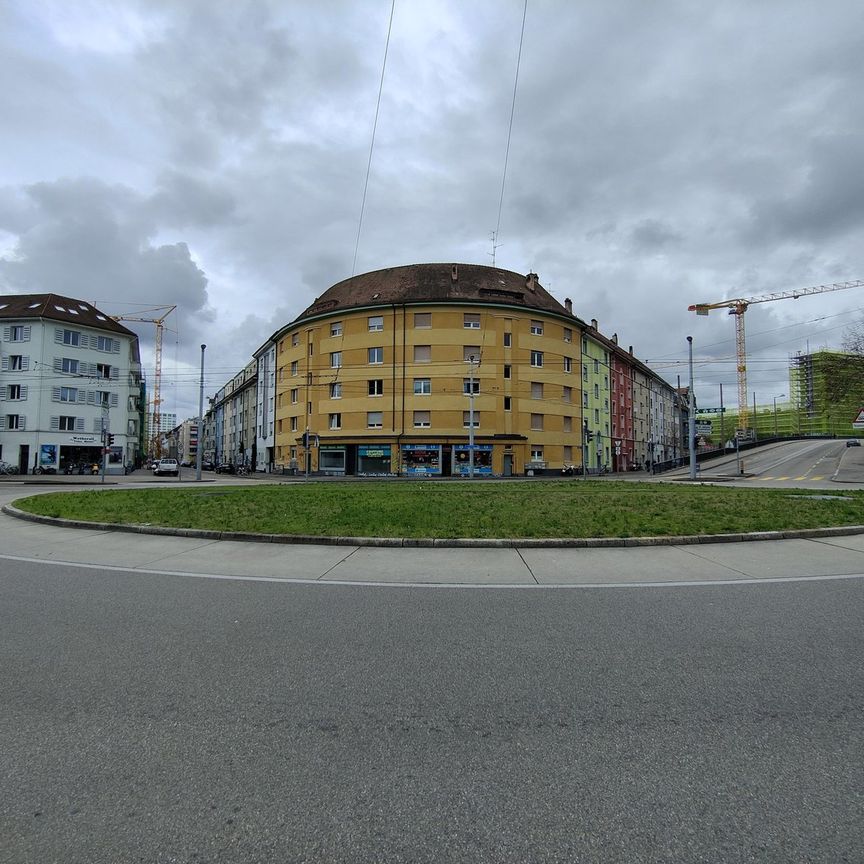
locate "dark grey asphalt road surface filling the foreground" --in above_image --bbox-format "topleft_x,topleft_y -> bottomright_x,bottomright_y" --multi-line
0,560 -> 864,864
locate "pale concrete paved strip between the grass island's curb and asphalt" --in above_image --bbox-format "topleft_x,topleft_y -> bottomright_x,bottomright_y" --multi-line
0,486 -> 864,588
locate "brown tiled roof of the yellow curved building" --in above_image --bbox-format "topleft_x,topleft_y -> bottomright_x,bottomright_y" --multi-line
294,264 -> 575,323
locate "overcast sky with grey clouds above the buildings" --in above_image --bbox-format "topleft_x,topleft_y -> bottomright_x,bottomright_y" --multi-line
0,0 -> 864,418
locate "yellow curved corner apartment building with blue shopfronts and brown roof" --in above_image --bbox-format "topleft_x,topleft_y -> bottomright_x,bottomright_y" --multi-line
273,264 -> 585,476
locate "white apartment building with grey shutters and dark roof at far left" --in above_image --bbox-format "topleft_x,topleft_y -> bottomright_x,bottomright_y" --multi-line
0,294 -> 142,473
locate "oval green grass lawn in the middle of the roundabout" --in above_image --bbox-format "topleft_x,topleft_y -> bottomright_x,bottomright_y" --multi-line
15,480 -> 864,538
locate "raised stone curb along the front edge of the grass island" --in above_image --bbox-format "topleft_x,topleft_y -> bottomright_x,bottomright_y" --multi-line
2,504 -> 864,549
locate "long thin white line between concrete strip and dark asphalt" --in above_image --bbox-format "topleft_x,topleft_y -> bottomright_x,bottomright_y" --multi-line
0,547 -> 864,591
